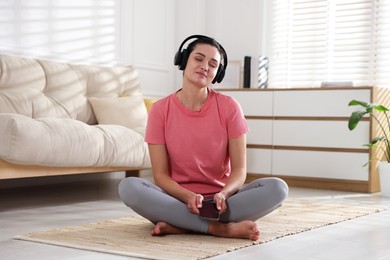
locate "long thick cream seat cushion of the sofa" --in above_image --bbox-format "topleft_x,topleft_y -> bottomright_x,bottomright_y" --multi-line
0,113 -> 150,167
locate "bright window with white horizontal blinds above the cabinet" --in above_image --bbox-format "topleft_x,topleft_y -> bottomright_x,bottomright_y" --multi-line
269,0 -> 390,88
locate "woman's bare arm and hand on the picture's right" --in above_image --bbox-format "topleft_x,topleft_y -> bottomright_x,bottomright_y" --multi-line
214,134 -> 246,213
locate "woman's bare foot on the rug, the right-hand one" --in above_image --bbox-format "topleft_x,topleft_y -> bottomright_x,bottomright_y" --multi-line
208,220 -> 260,241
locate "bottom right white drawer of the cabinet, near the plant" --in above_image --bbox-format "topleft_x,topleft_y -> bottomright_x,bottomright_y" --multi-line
272,150 -> 369,181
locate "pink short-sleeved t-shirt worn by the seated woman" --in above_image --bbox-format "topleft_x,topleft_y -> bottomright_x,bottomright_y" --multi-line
145,89 -> 248,194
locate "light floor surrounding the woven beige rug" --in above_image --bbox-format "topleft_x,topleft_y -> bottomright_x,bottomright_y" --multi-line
0,172 -> 390,260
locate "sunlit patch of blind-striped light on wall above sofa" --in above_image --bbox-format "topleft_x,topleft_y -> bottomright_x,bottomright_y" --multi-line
0,0 -> 120,64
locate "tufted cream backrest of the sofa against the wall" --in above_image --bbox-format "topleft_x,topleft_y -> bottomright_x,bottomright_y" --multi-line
0,54 -> 142,124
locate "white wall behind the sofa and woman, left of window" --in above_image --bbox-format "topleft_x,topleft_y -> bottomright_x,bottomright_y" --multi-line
0,0 -> 266,96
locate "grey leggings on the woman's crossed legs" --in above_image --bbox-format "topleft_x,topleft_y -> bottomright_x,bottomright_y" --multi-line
118,177 -> 288,233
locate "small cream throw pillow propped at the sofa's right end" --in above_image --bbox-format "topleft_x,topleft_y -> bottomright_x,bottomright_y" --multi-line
88,95 -> 148,130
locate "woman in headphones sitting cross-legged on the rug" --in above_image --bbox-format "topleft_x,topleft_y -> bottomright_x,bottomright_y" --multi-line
119,35 -> 288,240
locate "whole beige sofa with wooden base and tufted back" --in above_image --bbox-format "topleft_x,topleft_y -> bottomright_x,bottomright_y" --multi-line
0,54 -> 150,179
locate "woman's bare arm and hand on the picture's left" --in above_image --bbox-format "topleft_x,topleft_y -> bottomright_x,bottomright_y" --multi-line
148,144 -> 203,214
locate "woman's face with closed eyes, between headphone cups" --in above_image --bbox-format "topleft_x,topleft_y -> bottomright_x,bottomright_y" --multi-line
184,44 -> 221,87
